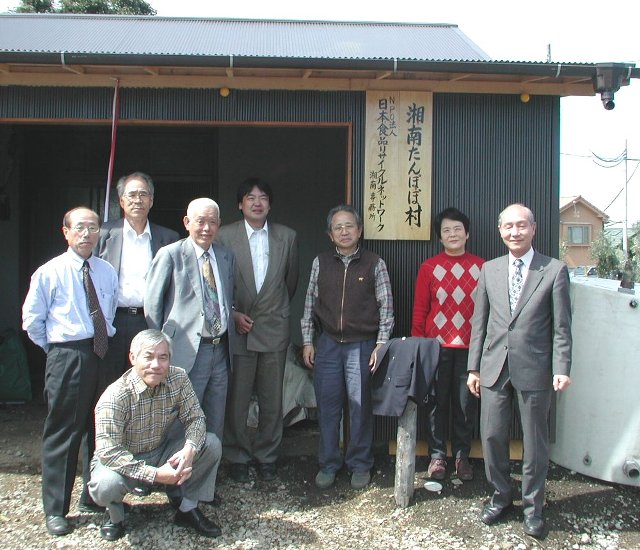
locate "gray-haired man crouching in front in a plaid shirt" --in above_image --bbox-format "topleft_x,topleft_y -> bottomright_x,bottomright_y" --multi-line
89,329 -> 222,540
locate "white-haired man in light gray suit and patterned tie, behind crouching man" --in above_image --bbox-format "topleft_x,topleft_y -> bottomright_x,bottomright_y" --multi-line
144,198 -> 235,441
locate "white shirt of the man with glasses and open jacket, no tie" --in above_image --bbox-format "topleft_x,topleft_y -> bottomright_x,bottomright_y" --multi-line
118,219 -> 153,307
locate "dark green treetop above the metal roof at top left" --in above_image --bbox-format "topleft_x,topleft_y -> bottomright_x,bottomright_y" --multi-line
15,0 -> 157,15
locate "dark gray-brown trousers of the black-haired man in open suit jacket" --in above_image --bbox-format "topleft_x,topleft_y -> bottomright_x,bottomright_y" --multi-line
224,349 -> 287,464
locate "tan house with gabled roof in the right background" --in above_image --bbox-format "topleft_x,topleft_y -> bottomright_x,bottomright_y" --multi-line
560,195 -> 609,267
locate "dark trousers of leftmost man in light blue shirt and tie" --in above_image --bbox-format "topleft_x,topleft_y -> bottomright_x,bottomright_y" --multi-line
42,338 -> 105,516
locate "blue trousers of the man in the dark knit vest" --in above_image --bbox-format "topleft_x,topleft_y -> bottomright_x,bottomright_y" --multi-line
313,334 -> 376,472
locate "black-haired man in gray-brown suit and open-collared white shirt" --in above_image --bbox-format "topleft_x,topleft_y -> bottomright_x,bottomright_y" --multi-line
218,178 -> 298,483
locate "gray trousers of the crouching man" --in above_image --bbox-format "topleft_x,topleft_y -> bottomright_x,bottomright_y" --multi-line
89,432 -> 222,523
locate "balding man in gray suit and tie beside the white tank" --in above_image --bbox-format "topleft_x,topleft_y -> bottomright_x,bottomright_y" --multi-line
467,204 -> 572,538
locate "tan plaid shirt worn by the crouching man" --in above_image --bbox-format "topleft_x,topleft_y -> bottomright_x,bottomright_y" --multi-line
95,367 -> 206,483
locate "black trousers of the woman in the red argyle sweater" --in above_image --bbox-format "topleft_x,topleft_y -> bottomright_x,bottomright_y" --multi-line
427,347 -> 478,459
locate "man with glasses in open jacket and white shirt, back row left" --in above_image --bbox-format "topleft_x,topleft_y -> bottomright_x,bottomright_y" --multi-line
94,172 -> 180,384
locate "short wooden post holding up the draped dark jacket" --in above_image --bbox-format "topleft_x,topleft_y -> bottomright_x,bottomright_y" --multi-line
394,399 -> 418,508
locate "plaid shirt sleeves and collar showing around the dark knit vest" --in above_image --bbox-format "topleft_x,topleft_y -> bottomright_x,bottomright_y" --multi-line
300,248 -> 394,346
